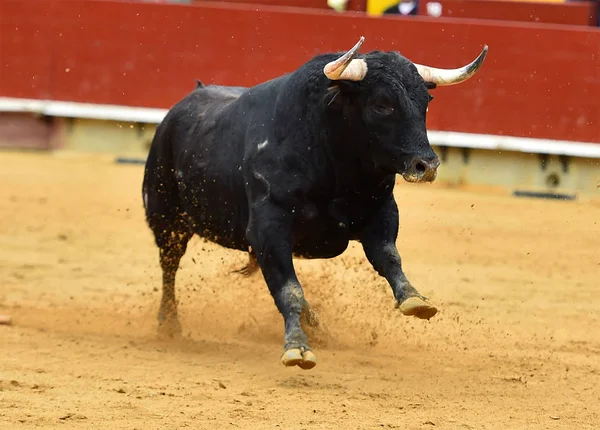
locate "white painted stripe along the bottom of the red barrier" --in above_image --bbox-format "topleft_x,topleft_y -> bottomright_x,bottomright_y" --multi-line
0,97 -> 600,158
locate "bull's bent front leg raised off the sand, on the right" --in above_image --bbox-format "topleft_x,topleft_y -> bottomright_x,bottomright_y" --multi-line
361,195 -> 437,320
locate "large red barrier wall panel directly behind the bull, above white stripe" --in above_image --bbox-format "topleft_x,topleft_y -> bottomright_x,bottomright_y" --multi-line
0,0 -> 600,143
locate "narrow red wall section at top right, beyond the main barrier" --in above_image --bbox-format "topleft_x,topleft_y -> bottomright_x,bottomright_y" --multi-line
419,0 -> 598,26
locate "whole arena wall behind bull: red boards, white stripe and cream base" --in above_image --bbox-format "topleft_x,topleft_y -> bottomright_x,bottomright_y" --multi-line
0,0 -> 600,196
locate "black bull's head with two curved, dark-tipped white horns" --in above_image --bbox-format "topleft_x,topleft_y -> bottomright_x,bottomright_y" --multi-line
323,37 -> 488,182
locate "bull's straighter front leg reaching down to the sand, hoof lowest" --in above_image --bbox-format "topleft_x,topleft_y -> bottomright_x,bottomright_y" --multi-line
247,202 -> 317,369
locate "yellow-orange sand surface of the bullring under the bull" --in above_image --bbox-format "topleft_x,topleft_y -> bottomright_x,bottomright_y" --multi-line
0,152 -> 600,429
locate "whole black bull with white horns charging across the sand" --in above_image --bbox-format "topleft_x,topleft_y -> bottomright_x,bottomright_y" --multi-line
143,38 -> 487,369
